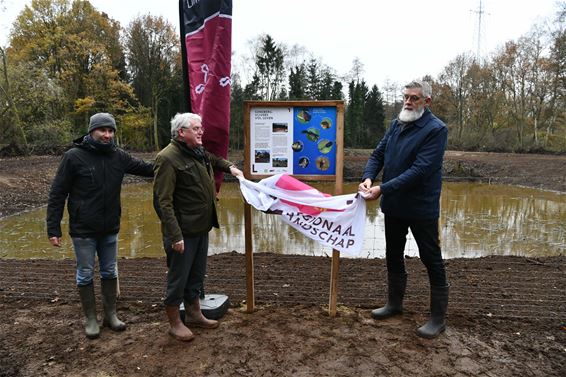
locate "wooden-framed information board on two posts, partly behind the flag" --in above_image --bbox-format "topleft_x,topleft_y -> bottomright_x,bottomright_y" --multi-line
244,101 -> 344,317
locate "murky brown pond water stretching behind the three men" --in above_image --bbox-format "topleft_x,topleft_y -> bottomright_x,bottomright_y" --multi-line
0,183 -> 566,259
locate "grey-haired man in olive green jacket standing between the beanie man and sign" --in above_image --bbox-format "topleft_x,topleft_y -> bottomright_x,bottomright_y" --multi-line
153,113 -> 243,341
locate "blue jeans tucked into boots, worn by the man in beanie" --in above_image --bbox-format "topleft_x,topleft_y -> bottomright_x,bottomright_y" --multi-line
73,234 -> 118,286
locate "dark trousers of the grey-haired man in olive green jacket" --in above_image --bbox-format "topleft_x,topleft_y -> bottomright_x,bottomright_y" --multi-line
163,233 -> 208,306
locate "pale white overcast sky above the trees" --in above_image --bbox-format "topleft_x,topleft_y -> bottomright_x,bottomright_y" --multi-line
0,0 -> 564,88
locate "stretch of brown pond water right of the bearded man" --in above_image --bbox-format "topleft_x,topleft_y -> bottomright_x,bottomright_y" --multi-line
441,183 -> 566,257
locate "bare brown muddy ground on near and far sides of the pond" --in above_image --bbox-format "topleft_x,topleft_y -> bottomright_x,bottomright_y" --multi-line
0,151 -> 566,377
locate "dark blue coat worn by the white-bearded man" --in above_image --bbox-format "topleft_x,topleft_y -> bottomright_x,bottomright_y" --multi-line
362,108 -> 448,219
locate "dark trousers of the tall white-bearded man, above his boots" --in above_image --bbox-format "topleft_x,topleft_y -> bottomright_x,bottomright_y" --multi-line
385,215 -> 447,287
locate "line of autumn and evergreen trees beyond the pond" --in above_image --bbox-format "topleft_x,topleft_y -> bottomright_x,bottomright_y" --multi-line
0,0 -> 566,153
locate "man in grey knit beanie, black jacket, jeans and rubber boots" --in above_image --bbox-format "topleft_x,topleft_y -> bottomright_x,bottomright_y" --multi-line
47,113 -> 153,339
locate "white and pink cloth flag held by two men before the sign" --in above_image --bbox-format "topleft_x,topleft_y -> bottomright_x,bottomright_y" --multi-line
240,174 -> 366,256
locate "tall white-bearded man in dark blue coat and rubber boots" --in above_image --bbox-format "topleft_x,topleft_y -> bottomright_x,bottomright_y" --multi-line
359,81 -> 449,338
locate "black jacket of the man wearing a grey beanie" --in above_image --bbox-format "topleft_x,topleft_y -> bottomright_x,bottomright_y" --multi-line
47,138 -> 153,237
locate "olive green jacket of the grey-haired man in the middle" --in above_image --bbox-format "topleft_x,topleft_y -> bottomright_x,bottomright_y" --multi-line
153,140 -> 232,243
